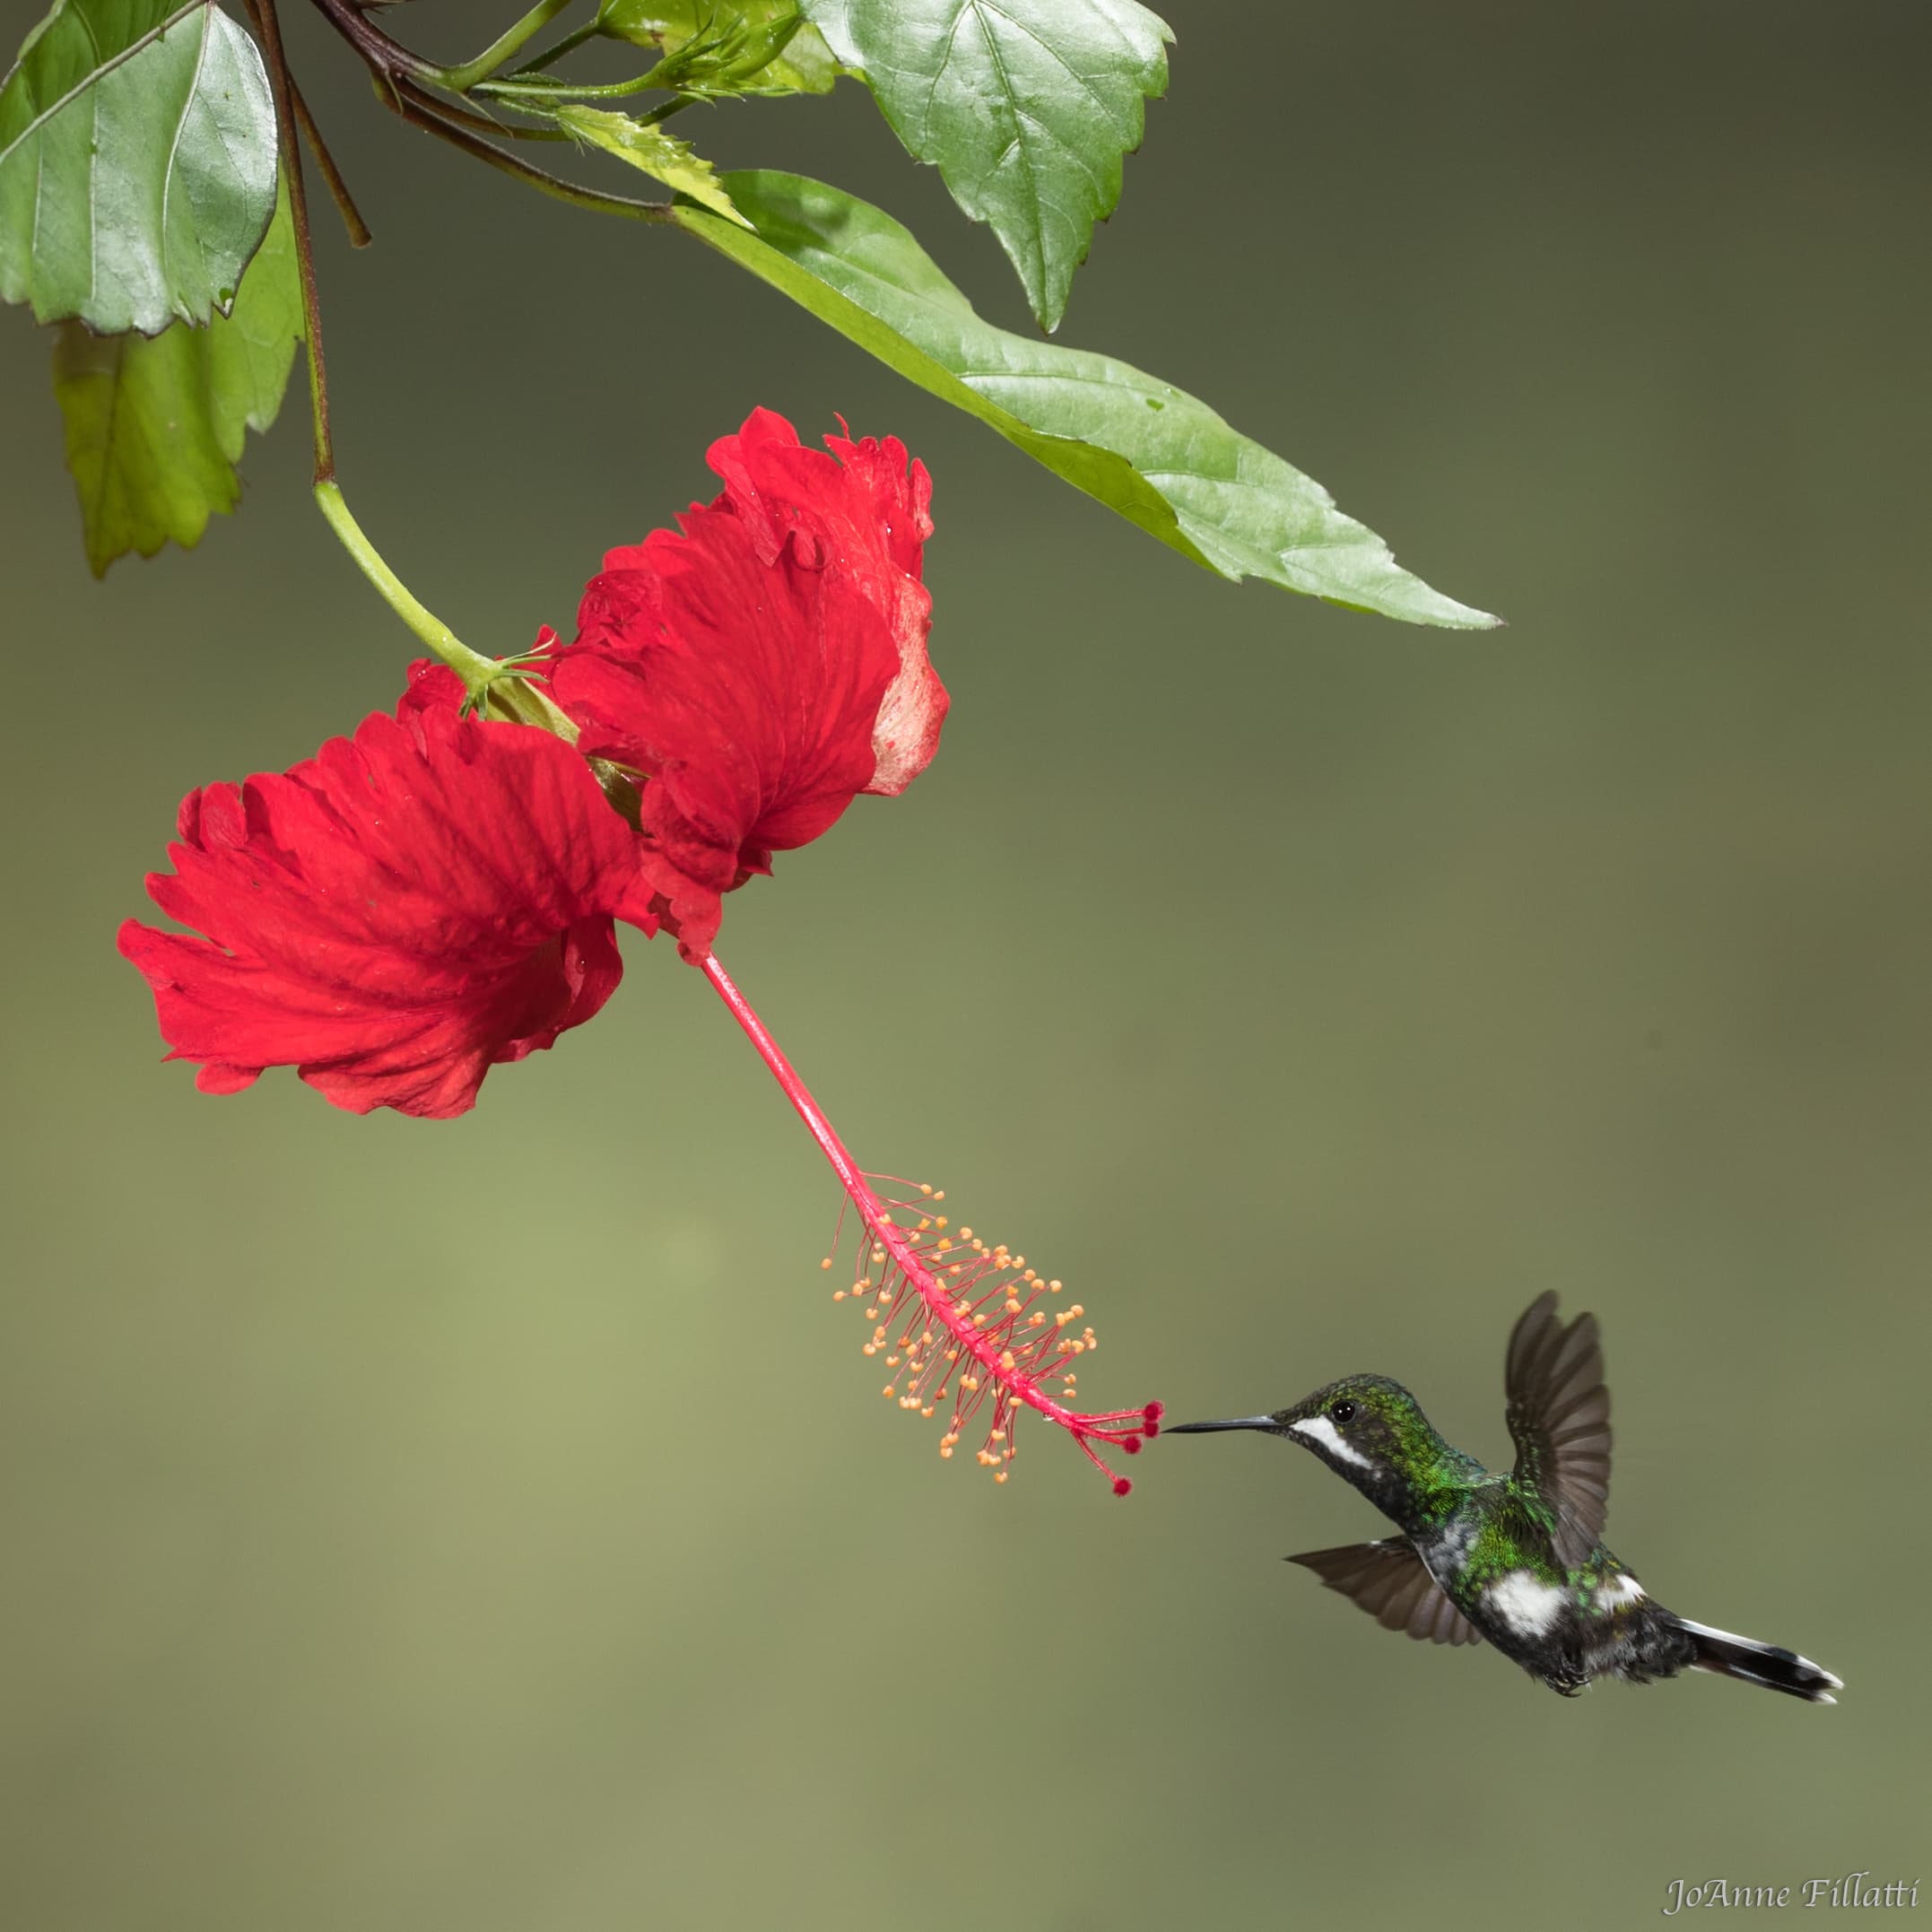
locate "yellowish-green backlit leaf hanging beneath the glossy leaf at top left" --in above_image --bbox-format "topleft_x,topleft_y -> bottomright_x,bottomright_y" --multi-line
54,177 -> 303,578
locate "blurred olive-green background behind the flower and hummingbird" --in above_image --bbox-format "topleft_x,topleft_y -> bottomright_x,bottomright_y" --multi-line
0,0 -> 1932,1932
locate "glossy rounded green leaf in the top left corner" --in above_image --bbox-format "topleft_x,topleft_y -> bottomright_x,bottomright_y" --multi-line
0,0 -> 274,336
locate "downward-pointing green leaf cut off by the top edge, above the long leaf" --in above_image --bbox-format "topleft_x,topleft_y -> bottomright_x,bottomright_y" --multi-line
802,0 -> 1172,332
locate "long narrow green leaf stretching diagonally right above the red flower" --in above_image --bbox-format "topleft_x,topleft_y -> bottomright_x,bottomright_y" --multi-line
676,172 -> 1497,630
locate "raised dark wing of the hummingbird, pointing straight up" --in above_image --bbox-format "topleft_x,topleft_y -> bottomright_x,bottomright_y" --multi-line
1503,1291 -> 1609,1569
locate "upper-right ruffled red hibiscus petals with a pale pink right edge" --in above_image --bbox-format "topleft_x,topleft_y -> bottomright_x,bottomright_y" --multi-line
551,410 -> 927,958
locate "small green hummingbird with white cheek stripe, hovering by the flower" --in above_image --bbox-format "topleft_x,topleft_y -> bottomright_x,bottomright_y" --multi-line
1162,1294 -> 1843,1704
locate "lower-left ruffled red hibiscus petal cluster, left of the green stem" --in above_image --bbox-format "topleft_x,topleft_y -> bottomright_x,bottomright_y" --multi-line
120,687 -> 657,1118
